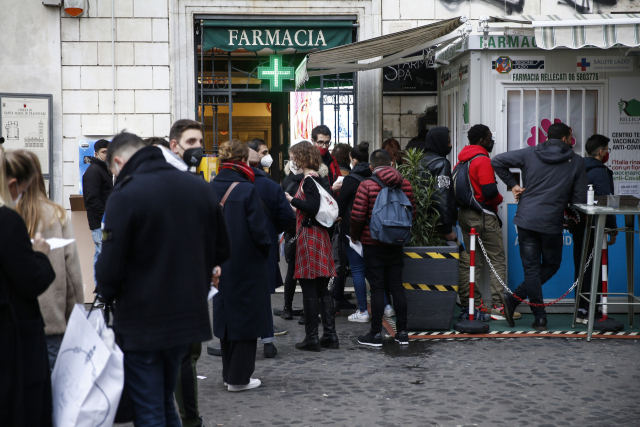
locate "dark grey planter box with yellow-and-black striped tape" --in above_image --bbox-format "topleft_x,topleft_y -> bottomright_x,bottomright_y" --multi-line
402,242 -> 459,331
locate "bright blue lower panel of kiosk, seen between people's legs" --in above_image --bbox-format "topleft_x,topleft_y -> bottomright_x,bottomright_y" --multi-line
507,204 -> 640,300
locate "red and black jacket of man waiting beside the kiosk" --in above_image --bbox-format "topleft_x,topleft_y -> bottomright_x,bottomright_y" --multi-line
456,145 -> 502,213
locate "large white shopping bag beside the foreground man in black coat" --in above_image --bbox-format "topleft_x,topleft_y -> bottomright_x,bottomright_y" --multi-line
51,304 -> 124,427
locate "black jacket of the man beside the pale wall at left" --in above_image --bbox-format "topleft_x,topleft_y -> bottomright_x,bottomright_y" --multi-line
82,157 -> 113,230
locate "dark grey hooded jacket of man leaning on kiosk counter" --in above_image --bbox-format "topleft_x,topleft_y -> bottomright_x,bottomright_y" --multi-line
491,139 -> 587,234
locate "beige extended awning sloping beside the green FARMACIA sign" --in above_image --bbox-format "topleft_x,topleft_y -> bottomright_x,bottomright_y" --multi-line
295,17 -> 466,88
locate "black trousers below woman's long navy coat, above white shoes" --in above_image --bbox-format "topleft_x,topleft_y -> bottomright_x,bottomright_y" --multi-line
220,338 -> 258,385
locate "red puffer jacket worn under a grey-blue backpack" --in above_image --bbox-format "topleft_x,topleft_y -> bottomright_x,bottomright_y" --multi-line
350,166 -> 417,245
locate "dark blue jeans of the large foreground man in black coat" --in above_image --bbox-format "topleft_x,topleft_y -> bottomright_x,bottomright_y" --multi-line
124,344 -> 191,427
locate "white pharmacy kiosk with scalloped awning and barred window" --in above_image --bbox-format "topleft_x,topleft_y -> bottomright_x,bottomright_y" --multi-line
436,15 -> 640,306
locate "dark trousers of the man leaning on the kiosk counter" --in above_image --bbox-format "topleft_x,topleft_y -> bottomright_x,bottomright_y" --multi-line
515,227 -> 562,318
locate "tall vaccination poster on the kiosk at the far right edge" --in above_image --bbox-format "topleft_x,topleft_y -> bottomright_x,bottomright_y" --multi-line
608,77 -> 640,197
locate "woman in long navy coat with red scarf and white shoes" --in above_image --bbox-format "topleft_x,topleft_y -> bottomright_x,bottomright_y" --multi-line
211,140 -> 272,391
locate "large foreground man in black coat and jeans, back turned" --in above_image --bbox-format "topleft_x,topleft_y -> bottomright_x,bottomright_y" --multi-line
96,133 -> 230,426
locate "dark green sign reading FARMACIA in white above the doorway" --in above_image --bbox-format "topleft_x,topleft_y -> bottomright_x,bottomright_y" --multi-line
203,20 -> 353,52
